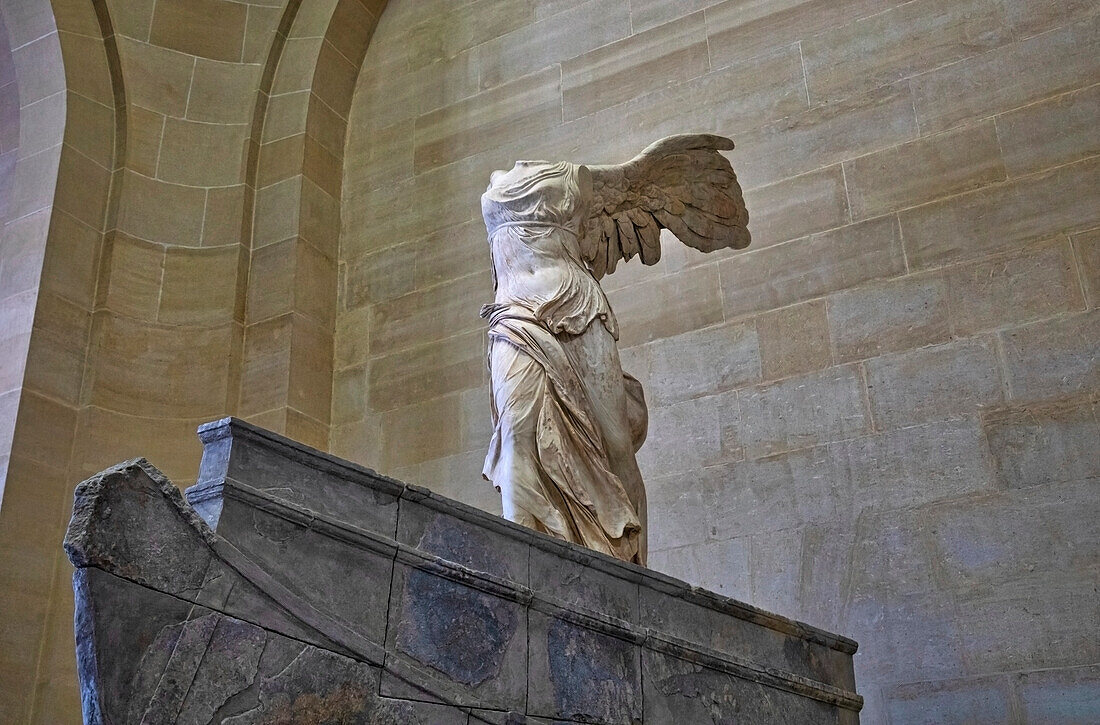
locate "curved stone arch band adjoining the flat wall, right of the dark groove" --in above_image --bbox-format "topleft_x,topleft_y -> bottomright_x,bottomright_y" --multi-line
237,0 -> 386,449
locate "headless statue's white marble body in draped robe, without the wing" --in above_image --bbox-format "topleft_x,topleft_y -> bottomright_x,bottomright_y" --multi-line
482,162 -> 647,563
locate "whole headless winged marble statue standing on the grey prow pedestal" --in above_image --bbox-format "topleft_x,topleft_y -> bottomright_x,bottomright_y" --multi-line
481,134 -> 749,564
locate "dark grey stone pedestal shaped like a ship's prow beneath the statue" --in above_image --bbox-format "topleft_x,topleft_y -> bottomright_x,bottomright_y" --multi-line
66,419 -> 862,725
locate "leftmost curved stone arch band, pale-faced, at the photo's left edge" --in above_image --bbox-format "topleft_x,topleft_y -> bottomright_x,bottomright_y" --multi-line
0,0 -> 125,722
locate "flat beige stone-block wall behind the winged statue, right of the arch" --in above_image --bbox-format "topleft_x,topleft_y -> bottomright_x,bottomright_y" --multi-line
331,0 -> 1100,725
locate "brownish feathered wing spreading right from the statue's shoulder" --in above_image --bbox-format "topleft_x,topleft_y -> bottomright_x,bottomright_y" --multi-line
581,134 -> 749,279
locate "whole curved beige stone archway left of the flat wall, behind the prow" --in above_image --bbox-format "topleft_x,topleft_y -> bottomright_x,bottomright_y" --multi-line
0,0 -> 385,723
